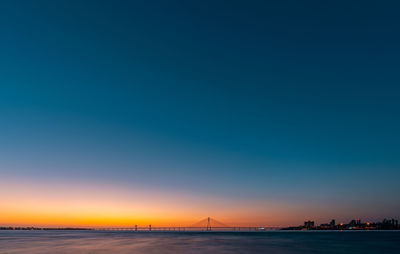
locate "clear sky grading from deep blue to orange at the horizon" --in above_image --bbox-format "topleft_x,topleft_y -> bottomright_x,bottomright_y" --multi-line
0,0 -> 400,227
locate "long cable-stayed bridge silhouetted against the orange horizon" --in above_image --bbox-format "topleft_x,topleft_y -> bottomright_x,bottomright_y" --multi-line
94,217 -> 280,232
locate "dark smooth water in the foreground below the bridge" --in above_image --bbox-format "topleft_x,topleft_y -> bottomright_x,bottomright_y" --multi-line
0,231 -> 400,254
